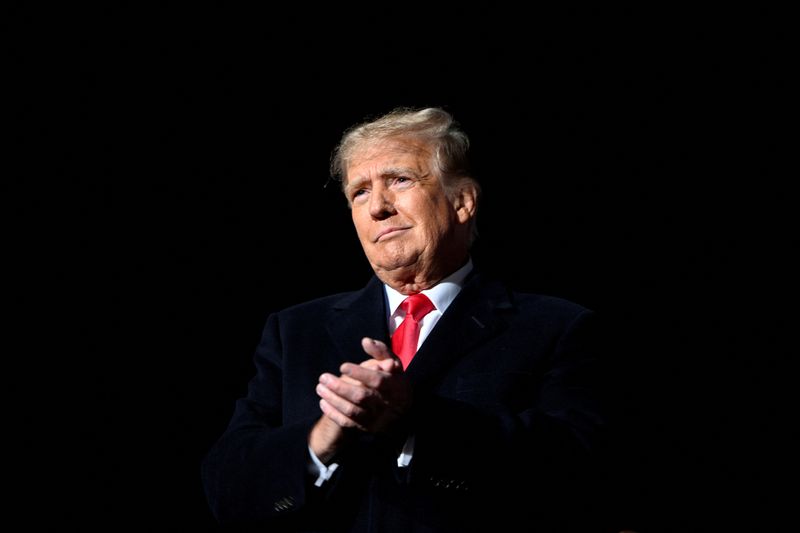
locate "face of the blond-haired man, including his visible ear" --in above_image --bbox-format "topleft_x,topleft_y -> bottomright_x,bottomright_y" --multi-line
345,138 -> 471,282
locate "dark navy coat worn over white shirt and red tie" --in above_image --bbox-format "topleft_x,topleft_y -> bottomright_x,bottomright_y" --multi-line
202,274 -> 607,532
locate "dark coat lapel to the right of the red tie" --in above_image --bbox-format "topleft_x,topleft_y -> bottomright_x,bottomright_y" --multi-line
406,274 -> 512,387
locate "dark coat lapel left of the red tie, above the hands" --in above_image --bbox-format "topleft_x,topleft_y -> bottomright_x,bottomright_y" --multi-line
326,276 -> 389,363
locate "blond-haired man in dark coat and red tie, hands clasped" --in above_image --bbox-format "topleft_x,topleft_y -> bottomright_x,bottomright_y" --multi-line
203,108 -> 607,532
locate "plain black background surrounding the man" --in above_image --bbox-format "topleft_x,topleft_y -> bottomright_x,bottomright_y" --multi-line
7,4 -> 797,532
